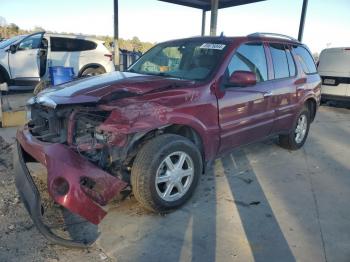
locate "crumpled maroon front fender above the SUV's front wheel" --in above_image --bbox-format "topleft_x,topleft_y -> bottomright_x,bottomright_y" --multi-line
100,86 -> 220,161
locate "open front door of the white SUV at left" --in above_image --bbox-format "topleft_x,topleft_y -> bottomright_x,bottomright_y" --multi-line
9,33 -> 43,80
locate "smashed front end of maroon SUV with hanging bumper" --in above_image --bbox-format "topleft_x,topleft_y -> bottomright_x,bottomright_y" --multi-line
14,104 -> 129,247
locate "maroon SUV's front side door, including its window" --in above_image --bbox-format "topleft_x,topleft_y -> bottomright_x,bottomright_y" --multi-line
218,43 -> 275,152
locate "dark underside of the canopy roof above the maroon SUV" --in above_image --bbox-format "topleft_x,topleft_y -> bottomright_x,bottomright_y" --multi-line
159,0 -> 265,11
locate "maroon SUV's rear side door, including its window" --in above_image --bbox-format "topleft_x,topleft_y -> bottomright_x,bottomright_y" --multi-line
269,43 -> 300,133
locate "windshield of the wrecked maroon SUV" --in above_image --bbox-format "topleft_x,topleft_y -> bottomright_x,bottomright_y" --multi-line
128,40 -> 227,80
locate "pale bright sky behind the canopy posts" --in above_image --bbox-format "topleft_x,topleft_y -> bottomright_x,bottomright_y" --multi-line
0,0 -> 350,52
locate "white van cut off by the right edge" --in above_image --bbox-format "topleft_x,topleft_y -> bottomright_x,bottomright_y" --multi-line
318,47 -> 350,101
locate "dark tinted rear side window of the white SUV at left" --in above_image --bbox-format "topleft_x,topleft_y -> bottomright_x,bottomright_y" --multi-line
51,37 -> 97,52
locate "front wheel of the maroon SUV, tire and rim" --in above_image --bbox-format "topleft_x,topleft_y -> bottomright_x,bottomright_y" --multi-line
131,134 -> 202,213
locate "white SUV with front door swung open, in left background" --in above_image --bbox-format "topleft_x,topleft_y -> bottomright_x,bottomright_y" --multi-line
0,32 -> 115,86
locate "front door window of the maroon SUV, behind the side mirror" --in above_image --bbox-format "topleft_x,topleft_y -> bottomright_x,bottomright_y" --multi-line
228,43 -> 267,83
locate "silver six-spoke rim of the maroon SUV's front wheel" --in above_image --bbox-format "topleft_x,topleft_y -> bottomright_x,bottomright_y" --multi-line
155,151 -> 194,202
